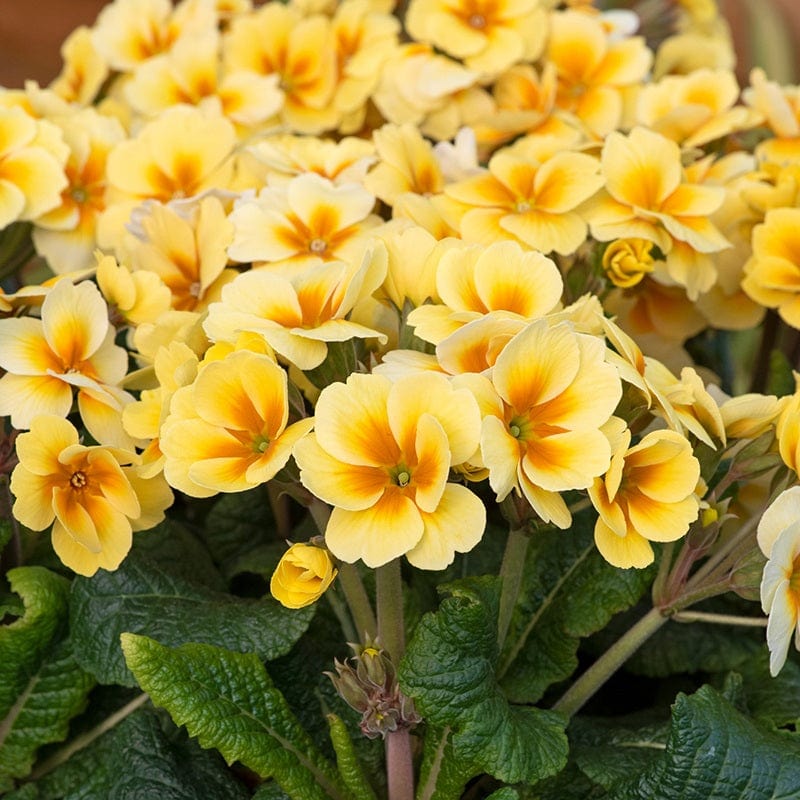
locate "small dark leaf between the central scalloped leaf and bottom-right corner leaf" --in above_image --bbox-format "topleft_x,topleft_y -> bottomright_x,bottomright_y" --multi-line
569,717 -> 669,789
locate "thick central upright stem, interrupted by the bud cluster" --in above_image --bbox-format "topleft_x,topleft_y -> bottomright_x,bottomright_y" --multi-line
375,558 -> 414,800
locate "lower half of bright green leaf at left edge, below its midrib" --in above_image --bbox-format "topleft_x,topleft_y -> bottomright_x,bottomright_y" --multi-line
0,640 -> 94,788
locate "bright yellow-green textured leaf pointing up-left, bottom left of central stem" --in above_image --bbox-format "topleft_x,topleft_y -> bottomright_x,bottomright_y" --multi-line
122,633 -> 348,800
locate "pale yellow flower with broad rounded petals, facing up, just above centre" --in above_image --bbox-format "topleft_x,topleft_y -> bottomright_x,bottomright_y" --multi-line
408,241 -> 564,344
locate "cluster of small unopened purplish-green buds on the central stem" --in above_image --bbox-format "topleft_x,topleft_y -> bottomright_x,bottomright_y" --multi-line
326,642 -> 421,739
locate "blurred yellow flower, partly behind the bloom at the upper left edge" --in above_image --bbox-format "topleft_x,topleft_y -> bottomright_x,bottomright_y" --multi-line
33,108 -> 125,274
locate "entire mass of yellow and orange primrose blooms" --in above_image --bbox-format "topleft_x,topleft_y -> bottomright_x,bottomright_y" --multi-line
0,0 -> 800,670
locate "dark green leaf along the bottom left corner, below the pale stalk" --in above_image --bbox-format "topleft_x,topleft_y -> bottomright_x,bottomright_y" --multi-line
7,708 -> 250,800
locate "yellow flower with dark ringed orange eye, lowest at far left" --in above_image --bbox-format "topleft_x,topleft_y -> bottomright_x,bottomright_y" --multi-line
11,415 -> 172,576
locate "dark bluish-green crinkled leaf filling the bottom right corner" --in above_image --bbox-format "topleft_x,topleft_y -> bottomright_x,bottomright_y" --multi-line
609,686 -> 800,800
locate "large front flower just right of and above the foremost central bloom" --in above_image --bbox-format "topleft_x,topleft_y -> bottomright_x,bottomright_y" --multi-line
481,320 -> 622,529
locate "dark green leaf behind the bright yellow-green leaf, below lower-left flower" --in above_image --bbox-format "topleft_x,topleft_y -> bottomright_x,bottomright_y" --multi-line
70,553 -> 314,686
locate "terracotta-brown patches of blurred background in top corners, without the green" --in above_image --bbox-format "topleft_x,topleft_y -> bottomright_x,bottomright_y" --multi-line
0,0 -> 800,87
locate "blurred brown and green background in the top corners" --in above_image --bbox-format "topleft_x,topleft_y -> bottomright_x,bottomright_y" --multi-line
0,0 -> 800,88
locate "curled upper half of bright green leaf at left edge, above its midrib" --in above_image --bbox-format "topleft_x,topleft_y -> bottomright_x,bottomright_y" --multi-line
0,567 -> 69,717
